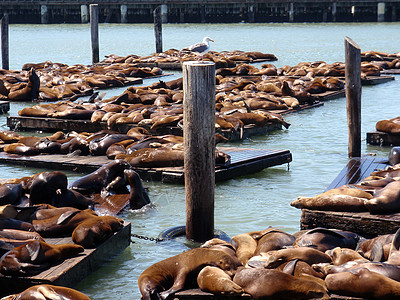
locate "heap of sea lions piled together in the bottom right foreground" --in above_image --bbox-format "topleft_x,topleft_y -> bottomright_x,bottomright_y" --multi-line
138,227 -> 400,300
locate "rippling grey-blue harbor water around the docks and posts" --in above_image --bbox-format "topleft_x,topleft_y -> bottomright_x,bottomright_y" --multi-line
0,23 -> 400,299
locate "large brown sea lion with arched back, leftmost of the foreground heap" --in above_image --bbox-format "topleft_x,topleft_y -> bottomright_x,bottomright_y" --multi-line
138,248 -> 237,300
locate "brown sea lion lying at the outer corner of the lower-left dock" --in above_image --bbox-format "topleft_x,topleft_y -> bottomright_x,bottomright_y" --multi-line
72,216 -> 124,249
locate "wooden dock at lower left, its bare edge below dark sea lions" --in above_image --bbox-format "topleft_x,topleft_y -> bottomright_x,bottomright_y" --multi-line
0,222 -> 131,297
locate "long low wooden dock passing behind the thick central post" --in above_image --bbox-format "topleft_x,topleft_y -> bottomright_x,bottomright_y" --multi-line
0,147 -> 292,183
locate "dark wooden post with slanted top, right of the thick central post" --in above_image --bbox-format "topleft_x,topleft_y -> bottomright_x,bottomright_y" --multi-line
344,36 -> 361,157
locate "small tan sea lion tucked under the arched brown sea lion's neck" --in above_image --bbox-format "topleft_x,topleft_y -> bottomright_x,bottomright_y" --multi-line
197,266 -> 243,295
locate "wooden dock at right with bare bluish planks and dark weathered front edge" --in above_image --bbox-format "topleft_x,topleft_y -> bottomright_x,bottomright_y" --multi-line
300,157 -> 400,238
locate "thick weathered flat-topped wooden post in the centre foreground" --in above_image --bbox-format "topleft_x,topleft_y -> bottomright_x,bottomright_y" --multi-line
183,61 -> 215,242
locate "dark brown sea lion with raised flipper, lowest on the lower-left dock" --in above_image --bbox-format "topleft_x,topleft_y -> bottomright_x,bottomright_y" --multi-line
0,240 -> 84,276
